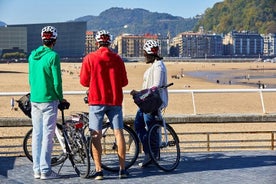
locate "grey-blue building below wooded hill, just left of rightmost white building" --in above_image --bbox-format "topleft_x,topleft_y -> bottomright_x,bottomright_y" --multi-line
223,31 -> 263,57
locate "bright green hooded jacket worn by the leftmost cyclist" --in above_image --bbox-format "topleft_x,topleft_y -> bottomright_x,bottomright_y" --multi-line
29,46 -> 63,103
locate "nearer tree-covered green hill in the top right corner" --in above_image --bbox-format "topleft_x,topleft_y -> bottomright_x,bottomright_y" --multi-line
194,0 -> 276,34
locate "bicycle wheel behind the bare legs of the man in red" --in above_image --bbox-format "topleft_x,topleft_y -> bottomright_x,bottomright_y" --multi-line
90,123 -> 140,172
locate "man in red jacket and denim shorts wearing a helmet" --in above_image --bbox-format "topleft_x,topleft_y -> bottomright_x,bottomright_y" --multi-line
80,30 -> 128,180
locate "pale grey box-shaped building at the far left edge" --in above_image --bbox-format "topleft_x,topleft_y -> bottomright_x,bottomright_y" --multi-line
0,27 -> 27,54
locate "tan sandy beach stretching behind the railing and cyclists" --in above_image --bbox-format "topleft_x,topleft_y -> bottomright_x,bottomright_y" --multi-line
0,62 -> 276,154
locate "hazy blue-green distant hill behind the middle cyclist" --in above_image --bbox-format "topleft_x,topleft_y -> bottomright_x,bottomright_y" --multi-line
74,8 -> 199,36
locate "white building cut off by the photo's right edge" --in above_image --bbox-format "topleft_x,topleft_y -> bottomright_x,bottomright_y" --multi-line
261,33 -> 276,56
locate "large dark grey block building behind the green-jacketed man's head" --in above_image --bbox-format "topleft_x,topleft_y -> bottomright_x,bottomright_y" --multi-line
6,22 -> 87,58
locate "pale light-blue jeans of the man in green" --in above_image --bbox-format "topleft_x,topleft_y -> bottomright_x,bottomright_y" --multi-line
31,100 -> 59,174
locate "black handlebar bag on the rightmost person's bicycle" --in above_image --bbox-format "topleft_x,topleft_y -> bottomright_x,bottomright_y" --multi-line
133,88 -> 163,113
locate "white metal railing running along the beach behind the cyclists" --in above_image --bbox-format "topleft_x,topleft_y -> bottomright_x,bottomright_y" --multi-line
0,88 -> 276,114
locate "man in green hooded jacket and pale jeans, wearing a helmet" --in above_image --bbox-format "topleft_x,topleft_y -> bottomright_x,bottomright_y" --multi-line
29,26 -> 63,179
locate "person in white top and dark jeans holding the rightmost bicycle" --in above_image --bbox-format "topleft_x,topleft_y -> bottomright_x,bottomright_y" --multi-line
131,40 -> 168,167
